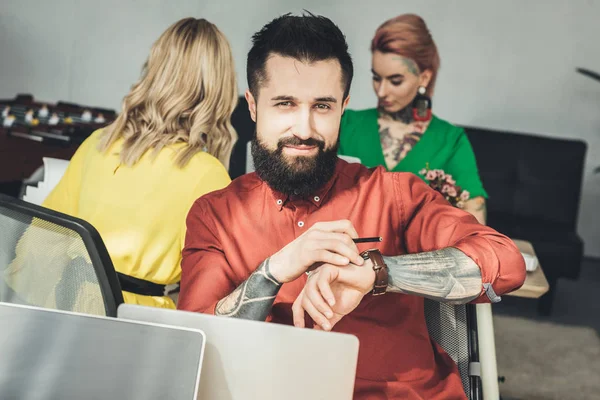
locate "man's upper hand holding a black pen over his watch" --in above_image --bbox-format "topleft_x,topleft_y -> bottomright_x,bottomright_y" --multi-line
270,220 -> 364,283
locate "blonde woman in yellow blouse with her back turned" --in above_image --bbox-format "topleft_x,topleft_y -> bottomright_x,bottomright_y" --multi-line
36,18 -> 238,308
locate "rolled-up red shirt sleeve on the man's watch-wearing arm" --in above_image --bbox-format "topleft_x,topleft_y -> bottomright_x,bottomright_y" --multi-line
394,174 -> 526,303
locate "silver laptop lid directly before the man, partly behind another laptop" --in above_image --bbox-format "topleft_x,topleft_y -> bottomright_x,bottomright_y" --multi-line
117,304 -> 358,400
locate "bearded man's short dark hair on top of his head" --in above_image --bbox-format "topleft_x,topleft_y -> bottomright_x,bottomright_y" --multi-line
246,11 -> 354,99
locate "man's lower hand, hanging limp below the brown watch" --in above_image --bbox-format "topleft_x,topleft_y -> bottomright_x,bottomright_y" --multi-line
292,260 -> 375,331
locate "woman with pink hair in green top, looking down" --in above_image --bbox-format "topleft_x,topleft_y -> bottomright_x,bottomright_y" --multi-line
339,14 -> 487,223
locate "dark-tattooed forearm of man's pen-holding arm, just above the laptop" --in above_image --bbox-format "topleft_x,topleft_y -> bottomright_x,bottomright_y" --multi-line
215,258 -> 281,321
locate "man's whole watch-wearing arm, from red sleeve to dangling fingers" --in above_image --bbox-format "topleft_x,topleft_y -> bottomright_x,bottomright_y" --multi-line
292,174 -> 525,330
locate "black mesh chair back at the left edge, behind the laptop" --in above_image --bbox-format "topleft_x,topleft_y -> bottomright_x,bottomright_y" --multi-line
0,195 -> 123,317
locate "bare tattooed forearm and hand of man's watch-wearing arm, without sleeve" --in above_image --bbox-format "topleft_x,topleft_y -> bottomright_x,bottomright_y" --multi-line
292,247 -> 482,330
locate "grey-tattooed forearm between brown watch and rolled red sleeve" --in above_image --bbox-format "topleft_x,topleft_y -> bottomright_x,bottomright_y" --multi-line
384,247 -> 482,304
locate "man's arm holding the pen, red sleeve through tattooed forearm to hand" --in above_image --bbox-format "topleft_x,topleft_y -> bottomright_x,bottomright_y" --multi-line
177,197 -> 364,320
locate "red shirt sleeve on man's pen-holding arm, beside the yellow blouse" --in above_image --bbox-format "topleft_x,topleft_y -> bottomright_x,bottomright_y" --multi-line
177,198 -> 235,314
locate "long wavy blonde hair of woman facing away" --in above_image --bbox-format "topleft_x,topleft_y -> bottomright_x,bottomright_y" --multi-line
98,18 -> 238,168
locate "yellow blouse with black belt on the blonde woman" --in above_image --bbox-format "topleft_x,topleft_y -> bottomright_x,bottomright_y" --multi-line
43,130 -> 231,308
